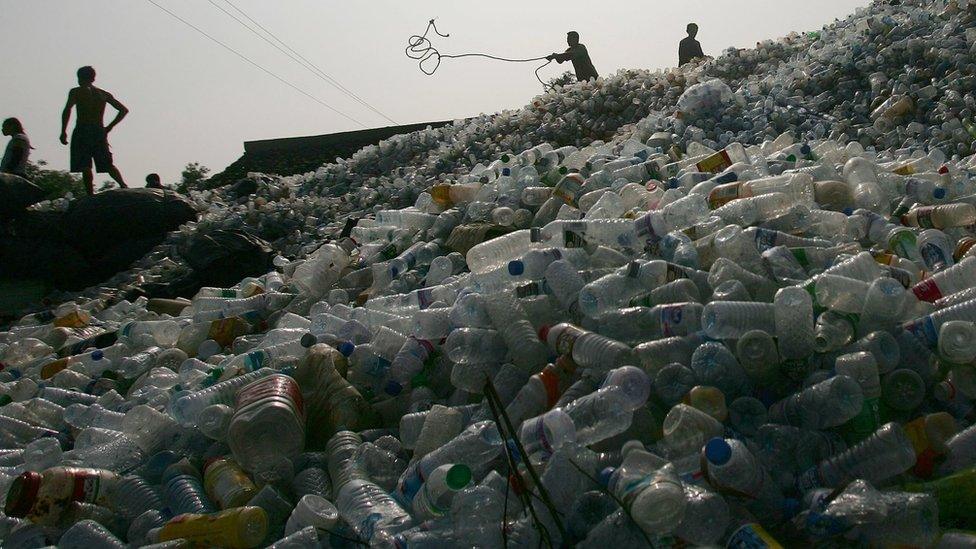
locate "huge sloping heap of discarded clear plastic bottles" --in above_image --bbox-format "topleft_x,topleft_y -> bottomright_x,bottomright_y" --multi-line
0,1 -> 976,548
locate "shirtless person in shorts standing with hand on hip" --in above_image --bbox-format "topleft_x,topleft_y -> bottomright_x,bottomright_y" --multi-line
61,67 -> 129,194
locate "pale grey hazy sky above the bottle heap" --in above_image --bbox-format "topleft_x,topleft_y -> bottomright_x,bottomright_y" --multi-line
0,0 -> 868,185
